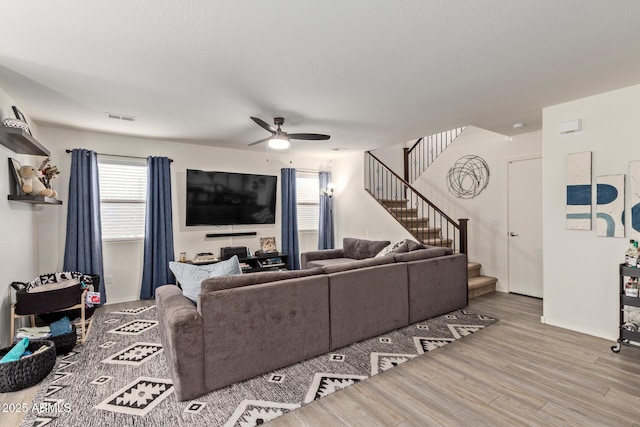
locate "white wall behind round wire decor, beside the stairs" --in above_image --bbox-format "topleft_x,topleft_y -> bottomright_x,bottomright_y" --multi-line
414,126 -> 542,292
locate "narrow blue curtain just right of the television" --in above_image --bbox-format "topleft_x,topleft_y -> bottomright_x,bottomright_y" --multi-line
280,168 -> 300,270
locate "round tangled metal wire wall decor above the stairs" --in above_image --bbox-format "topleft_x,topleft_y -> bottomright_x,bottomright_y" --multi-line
447,156 -> 489,199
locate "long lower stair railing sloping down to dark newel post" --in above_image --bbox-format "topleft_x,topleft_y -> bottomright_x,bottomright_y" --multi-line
364,151 -> 469,254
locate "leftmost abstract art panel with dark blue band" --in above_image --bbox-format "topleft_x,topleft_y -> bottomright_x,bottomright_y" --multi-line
566,151 -> 591,230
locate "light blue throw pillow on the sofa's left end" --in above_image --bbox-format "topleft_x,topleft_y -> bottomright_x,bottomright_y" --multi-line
169,255 -> 242,303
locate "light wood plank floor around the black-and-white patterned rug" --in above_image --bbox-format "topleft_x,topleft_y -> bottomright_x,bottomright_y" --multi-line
0,293 -> 640,427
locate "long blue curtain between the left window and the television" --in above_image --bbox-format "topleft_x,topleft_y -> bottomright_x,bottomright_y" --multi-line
140,157 -> 175,299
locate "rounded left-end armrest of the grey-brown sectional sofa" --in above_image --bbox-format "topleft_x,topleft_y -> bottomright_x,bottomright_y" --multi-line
156,285 -> 205,401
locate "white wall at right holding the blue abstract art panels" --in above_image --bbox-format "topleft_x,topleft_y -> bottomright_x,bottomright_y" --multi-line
543,85 -> 640,340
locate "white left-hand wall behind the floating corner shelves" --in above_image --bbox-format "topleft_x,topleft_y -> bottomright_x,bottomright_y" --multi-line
0,89 -> 43,347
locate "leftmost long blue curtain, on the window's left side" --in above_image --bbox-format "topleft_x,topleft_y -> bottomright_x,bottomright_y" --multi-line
63,149 -> 107,305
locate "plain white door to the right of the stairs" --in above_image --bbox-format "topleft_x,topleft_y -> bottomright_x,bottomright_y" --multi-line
508,158 -> 542,298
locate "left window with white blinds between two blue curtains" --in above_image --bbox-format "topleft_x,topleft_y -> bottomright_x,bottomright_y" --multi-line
98,155 -> 147,240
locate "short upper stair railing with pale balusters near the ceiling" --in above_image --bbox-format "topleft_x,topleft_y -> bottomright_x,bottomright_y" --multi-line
403,127 -> 464,182
